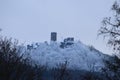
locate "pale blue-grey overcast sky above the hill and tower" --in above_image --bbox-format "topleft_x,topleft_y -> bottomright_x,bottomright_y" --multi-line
0,0 -> 114,53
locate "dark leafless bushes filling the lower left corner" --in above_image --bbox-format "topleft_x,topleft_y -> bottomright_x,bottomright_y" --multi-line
0,38 -> 44,80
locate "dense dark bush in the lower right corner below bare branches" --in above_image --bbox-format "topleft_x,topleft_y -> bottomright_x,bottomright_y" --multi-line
102,56 -> 120,80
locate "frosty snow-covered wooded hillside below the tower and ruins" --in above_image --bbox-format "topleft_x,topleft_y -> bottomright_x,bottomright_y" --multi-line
27,41 -> 109,70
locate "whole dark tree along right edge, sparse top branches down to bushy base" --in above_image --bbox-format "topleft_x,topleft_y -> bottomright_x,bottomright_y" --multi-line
99,1 -> 120,80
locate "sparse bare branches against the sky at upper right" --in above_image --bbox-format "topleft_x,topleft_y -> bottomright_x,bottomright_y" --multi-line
98,1 -> 120,53
